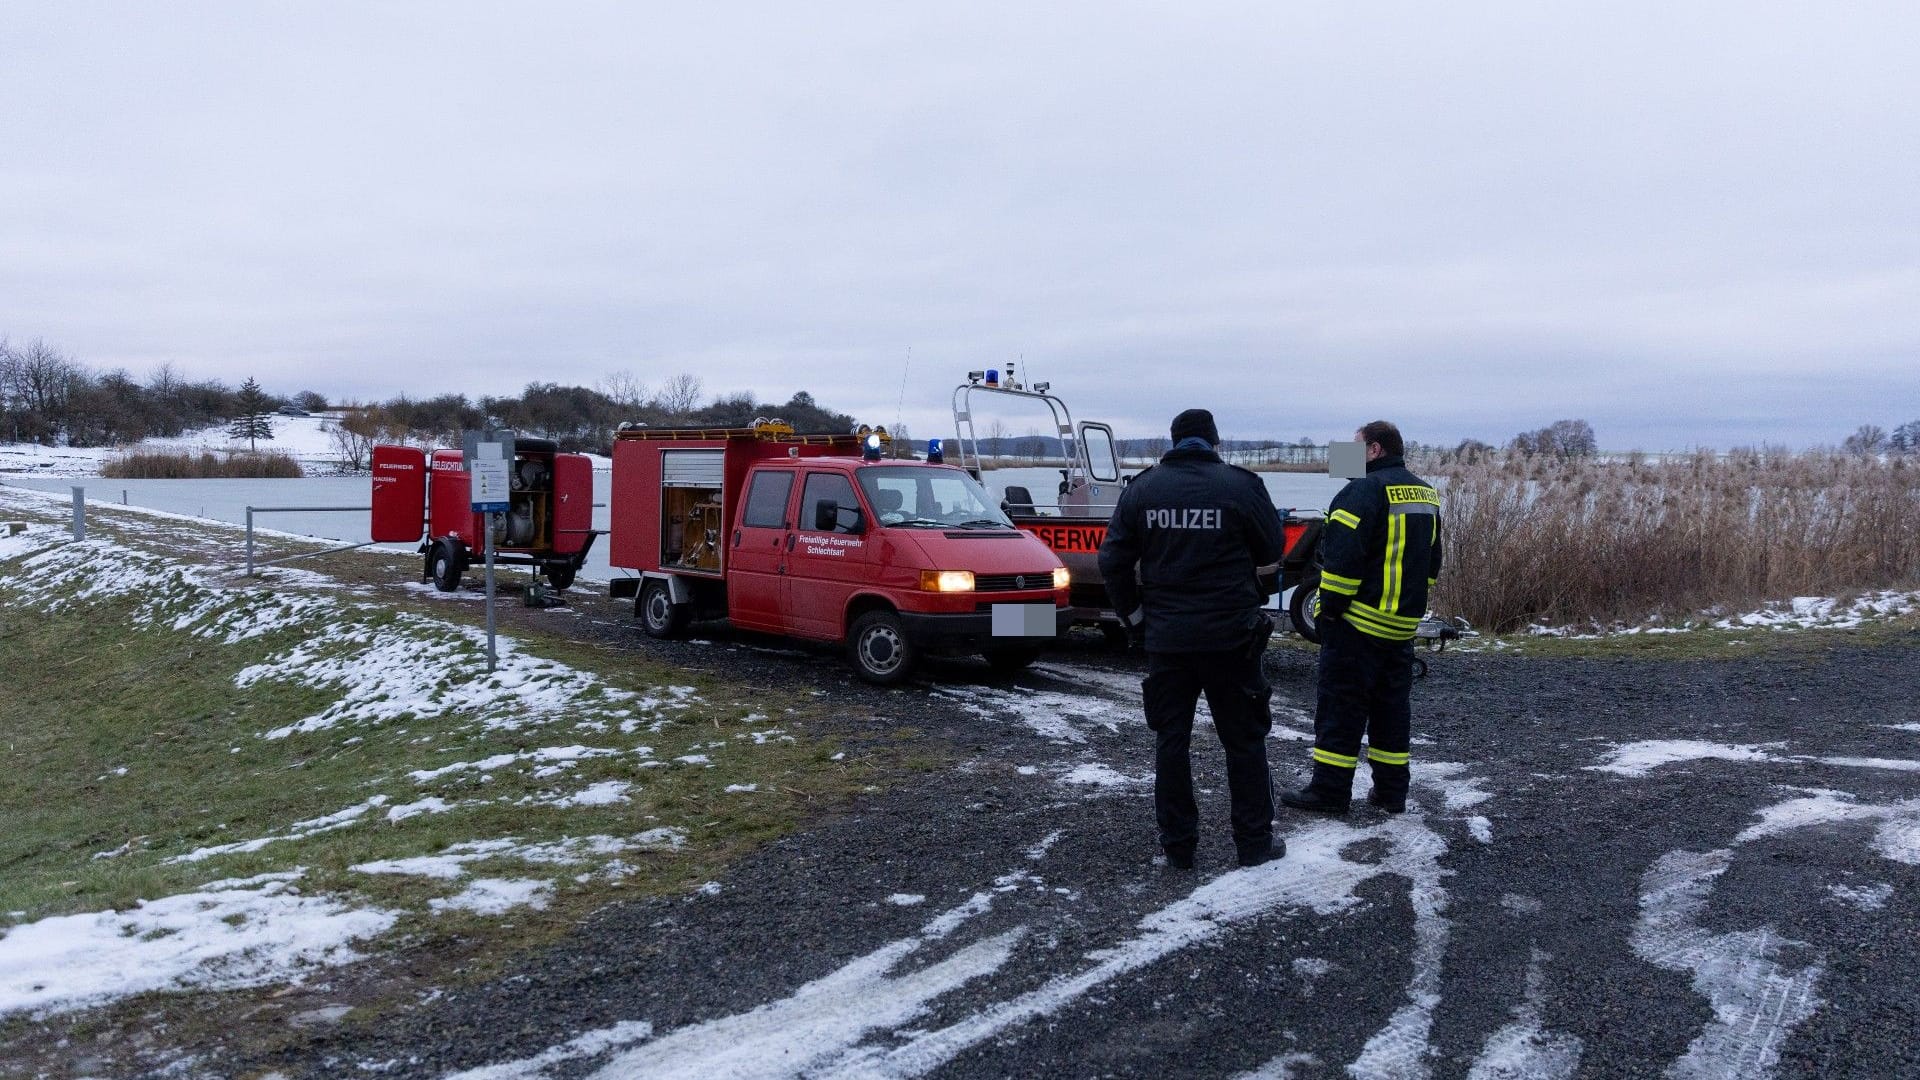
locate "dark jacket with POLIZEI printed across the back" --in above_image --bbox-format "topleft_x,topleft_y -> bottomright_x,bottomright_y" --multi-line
1100,448 -> 1286,653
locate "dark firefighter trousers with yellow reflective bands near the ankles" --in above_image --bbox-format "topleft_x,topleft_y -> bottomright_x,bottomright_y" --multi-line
1313,619 -> 1413,798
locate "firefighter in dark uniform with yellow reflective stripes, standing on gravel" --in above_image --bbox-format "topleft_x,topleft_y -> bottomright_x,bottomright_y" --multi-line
1281,421 -> 1440,813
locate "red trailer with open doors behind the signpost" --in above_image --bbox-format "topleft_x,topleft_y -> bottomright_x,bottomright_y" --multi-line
372,438 -> 595,592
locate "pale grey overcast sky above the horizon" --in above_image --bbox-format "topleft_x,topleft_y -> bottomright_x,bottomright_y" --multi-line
0,0 -> 1920,450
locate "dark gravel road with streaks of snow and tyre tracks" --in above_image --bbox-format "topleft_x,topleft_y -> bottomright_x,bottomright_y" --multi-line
232,601 -> 1920,1080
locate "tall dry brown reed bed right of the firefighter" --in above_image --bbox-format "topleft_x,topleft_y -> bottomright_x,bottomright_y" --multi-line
1432,452 -> 1920,632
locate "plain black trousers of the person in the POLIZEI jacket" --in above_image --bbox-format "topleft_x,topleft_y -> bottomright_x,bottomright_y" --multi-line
1140,638 -> 1273,853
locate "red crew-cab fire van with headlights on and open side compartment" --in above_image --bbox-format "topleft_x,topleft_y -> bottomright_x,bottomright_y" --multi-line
609,421 -> 1071,684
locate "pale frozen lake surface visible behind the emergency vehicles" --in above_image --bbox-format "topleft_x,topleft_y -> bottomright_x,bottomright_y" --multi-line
4,457 -> 1344,580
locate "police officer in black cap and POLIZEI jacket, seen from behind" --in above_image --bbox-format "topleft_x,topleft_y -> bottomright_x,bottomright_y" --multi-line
1100,409 -> 1286,869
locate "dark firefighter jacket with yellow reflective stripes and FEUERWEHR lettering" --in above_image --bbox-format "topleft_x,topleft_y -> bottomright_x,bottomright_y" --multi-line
1321,457 -> 1440,642
